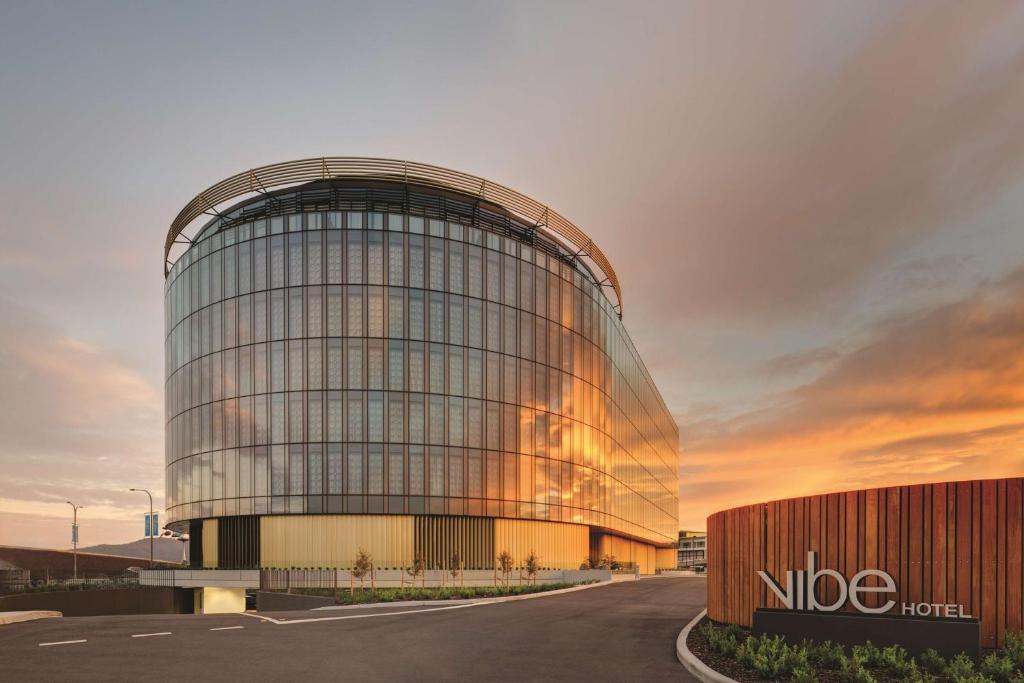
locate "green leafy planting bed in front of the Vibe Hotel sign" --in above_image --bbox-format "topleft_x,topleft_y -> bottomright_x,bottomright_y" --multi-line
686,618 -> 1024,683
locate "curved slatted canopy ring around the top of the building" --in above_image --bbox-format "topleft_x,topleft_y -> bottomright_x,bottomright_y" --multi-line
164,157 -> 623,314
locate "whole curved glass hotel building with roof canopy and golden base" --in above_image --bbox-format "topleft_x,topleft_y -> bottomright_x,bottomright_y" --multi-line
165,158 -> 678,572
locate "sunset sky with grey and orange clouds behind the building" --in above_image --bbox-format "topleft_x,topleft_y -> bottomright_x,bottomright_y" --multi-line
0,0 -> 1024,547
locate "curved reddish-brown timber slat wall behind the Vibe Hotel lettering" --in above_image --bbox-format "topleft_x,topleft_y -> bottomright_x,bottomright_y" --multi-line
708,478 -> 1024,647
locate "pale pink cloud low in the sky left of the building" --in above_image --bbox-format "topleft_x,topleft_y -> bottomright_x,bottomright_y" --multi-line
0,299 -> 163,545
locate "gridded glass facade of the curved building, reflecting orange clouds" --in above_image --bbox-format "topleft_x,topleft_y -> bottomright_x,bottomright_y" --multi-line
166,183 -> 678,544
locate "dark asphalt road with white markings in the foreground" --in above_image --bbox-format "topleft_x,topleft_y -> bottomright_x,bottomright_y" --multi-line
0,579 -> 706,683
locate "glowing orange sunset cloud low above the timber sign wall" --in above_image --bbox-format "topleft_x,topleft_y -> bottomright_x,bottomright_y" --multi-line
680,270 -> 1024,527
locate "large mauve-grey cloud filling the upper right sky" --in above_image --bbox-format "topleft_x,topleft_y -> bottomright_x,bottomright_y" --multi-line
609,4 -> 1024,325
